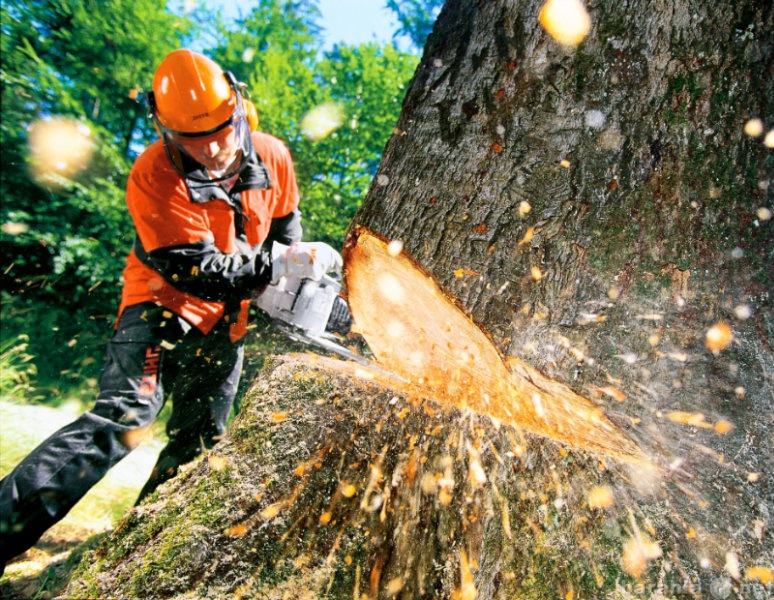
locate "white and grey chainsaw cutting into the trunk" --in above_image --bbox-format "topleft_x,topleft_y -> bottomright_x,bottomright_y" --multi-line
256,275 -> 370,365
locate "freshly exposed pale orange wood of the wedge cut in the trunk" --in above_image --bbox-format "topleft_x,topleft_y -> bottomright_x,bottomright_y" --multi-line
343,228 -> 650,465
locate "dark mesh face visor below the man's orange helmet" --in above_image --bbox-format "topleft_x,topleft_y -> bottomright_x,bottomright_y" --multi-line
151,92 -> 252,183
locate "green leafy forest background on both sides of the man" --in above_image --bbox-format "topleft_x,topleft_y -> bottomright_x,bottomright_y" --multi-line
0,0 -> 424,402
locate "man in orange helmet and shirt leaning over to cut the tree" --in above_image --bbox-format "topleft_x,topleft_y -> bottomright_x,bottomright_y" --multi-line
0,50 -> 341,565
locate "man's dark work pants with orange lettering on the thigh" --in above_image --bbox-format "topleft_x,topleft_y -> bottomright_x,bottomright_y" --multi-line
0,303 -> 243,564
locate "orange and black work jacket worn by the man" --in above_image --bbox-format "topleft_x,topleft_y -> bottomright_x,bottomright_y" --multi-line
119,132 -> 301,341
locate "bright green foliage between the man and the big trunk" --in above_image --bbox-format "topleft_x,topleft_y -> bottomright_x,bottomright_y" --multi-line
212,0 -> 417,246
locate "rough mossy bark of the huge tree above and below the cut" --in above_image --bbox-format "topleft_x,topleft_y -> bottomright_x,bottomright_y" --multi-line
62,0 -> 774,599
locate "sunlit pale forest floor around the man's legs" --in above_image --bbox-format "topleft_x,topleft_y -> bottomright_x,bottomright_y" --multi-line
0,401 -> 162,600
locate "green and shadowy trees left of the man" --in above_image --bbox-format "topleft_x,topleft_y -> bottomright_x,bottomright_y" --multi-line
0,0 -> 191,384
